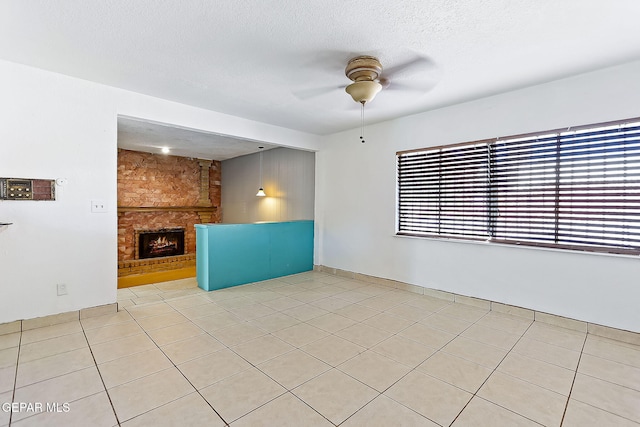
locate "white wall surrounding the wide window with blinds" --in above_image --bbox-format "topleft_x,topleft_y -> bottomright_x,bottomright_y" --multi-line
315,61 -> 640,331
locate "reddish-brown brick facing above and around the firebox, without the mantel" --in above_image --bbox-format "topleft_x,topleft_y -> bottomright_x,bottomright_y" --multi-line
118,150 -> 221,261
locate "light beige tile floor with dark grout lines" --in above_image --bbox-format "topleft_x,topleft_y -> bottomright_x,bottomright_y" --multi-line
0,272 -> 640,427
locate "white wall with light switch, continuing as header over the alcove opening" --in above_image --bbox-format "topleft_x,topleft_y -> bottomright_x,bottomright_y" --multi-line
0,61 -> 319,323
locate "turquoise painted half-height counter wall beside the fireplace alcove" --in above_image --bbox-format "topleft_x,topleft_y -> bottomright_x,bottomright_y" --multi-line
195,221 -> 313,291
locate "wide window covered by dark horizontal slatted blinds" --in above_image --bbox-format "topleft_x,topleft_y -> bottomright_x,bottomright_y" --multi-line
397,119 -> 640,254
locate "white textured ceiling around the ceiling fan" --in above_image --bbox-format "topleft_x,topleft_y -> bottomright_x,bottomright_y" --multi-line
0,0 -> 640,150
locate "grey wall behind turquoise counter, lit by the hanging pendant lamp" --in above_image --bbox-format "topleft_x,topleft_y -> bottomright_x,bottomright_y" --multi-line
222,148 -> 315,223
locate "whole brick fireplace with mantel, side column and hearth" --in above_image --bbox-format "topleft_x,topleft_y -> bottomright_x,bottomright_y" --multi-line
118,150 -> 221,277
